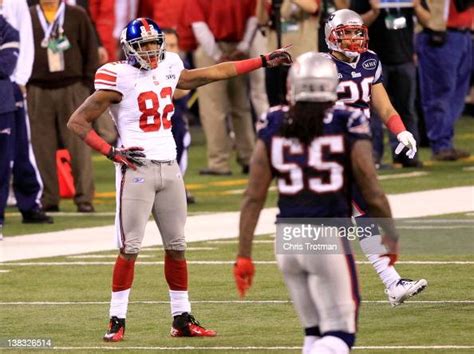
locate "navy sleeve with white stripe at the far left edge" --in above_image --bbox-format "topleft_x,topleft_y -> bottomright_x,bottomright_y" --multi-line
0,17 -> 20,78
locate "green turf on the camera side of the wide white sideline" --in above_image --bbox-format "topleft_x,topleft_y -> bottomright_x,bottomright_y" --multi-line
0,215 -> 474,353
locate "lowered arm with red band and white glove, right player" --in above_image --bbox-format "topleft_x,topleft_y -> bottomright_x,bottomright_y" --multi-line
372,83 -> 417,159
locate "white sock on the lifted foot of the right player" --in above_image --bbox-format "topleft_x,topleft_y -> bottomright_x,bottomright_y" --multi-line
359,235 -> 400,289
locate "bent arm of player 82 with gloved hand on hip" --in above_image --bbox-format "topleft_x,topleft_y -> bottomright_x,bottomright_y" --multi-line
67,90 -> 145,170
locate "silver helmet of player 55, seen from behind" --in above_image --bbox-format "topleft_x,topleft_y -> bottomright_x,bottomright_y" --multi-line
287,52 -> 339,105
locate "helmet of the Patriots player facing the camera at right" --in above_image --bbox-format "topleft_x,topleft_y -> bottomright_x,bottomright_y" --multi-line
324,9 -> 369,58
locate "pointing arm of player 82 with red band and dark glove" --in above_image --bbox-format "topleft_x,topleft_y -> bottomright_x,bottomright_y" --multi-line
177,47 -> 292,90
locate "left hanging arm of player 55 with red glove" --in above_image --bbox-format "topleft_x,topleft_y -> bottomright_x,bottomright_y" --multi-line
234,140 -> 272,297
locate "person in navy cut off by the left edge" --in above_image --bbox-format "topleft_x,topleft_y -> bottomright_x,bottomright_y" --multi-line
0,16 -> 20,239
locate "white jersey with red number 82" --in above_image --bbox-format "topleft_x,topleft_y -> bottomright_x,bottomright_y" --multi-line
94,52 -> 184,161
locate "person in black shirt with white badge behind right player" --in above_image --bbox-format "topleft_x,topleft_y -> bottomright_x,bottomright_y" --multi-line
351,0 -> 430,167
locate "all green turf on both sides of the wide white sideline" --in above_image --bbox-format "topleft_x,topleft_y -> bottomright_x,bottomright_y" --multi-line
0,118 -> 474,354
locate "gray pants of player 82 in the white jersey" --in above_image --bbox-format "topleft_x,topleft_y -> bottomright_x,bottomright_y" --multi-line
115,160 -> 187,254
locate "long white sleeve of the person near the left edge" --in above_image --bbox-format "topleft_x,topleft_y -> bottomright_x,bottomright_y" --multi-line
13,1 -> 35,86
